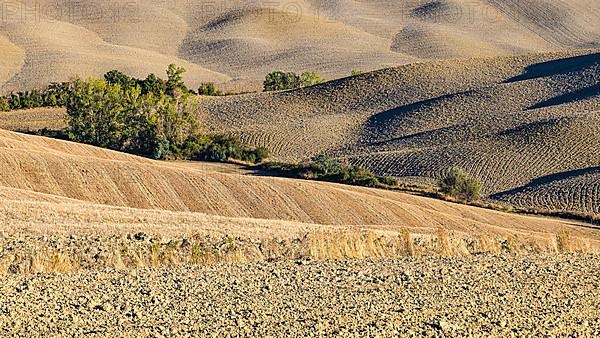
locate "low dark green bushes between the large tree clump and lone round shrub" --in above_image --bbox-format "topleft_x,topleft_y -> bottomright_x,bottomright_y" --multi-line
262,155 -> 398,187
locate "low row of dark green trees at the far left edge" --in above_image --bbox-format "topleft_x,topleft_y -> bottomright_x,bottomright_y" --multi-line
0,82 -> 71,111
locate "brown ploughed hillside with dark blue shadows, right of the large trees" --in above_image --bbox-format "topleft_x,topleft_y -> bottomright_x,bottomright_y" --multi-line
192,51 -> 600,213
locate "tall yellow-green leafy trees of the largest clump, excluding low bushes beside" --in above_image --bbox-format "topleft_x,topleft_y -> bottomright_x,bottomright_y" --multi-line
67,79 -> 198,158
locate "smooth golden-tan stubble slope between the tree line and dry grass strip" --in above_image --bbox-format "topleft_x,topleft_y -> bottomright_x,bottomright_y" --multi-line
0,131 -> 600,247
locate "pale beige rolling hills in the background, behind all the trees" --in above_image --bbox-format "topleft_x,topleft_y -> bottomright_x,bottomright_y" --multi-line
0,0 -> 600,92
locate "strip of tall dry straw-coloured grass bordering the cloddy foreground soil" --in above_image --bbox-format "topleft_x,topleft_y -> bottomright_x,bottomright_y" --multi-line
0,227 -> 594,274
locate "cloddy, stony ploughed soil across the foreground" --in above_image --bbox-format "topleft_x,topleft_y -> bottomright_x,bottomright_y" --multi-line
0,255 -> 600,337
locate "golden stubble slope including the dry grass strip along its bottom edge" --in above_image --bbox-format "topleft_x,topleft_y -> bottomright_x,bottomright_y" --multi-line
0,131 -> 600,271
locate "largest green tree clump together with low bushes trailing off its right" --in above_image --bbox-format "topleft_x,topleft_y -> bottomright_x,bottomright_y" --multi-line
66,65 -> 268,163
